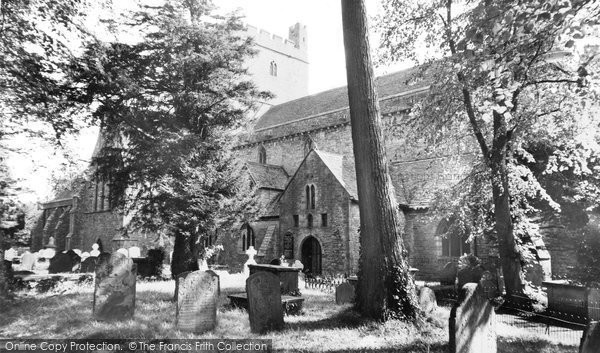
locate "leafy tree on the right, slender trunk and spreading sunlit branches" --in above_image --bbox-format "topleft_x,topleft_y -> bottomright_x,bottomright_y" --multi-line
377,0 -> 599,292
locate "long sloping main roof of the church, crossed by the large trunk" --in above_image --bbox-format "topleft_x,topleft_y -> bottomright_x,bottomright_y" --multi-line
254,68 -> 429,130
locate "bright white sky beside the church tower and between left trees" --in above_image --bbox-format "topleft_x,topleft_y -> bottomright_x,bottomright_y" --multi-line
8,0 -> 407,202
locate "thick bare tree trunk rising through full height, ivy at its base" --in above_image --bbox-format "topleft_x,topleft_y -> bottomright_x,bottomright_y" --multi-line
342,0 -> 418,320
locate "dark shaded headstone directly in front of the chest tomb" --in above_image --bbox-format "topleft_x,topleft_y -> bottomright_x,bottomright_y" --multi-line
246,271 -> 283,333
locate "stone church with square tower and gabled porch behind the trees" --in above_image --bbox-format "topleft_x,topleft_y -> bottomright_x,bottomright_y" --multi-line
32,24 -> 550,280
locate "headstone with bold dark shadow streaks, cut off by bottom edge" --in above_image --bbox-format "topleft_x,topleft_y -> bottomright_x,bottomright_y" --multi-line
449,283 -> 497,353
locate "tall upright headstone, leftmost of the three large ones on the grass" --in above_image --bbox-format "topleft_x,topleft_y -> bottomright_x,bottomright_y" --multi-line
93,253 -> 136,320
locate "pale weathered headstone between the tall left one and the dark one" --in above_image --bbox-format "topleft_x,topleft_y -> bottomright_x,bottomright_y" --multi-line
176,271 -> 219,333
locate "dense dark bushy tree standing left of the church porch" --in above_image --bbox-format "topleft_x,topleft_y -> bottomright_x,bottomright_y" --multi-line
73,0 -> 270,264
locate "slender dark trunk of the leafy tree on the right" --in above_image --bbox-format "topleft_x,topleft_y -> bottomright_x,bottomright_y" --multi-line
490,111 -> 524,295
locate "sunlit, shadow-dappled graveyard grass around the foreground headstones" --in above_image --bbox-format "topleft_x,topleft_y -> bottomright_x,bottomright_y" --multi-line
0,275 -> 577,353
